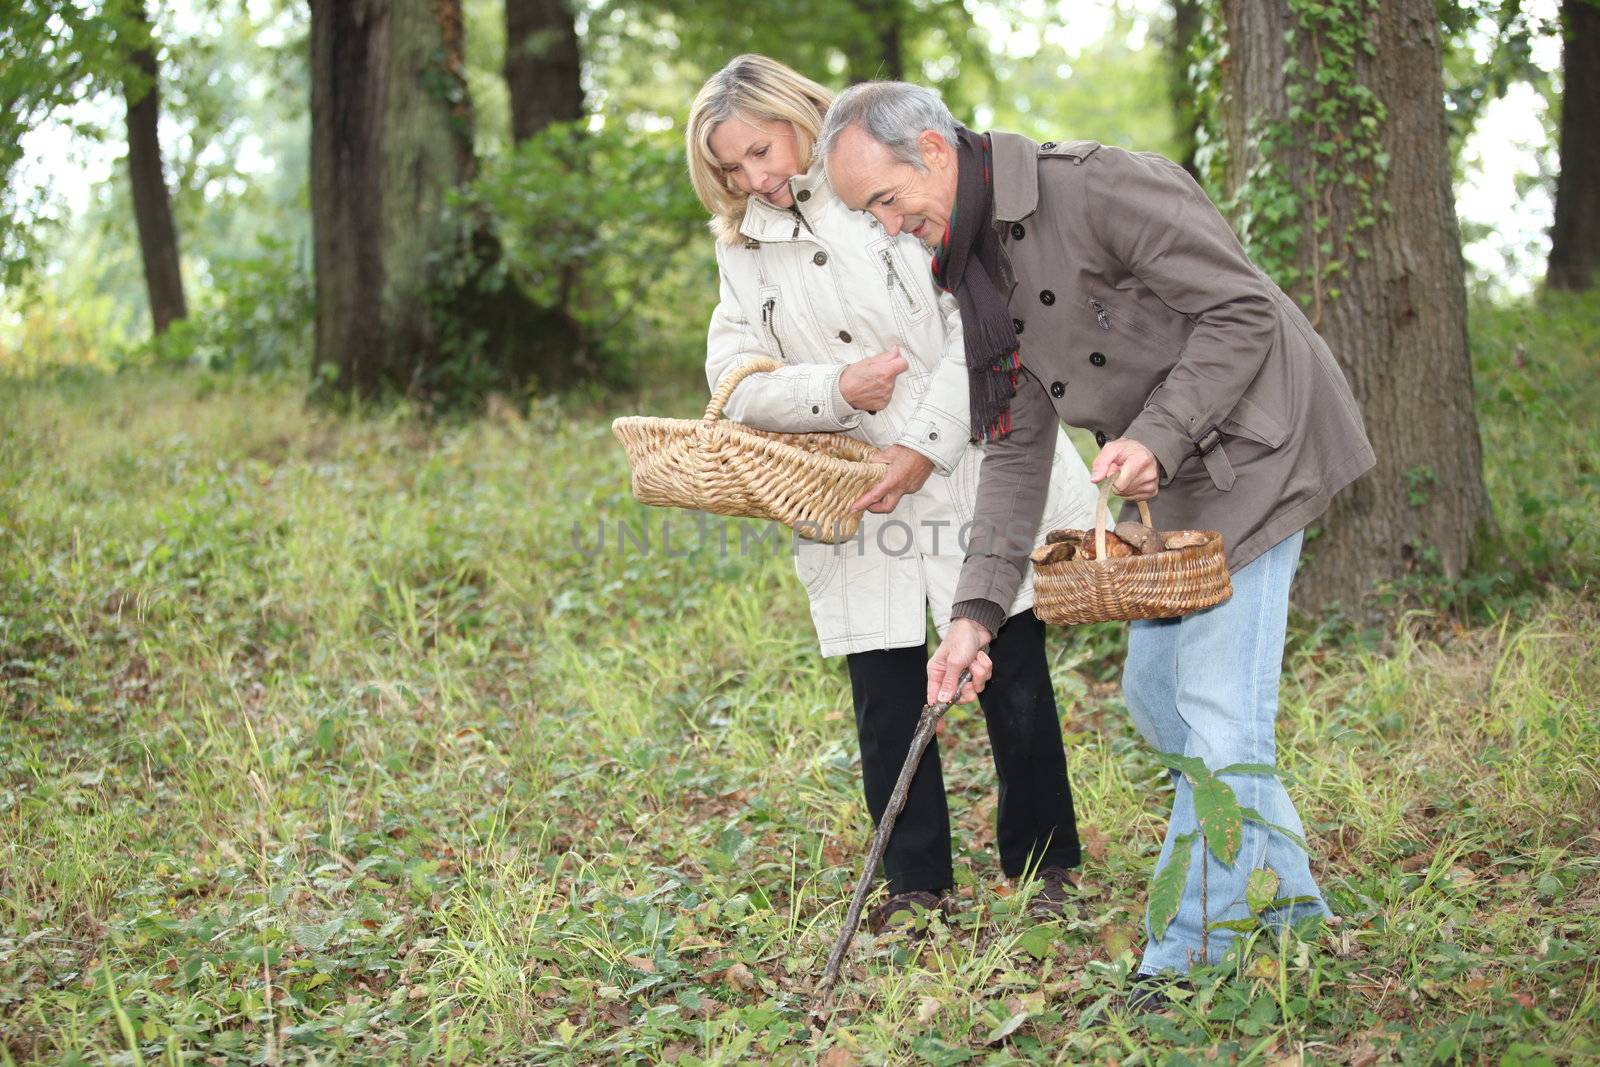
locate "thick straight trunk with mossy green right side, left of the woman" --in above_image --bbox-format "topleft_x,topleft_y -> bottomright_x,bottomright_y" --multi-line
310,0 -> 472,397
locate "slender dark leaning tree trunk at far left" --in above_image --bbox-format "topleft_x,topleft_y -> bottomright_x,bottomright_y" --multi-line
123,3 -> 189,334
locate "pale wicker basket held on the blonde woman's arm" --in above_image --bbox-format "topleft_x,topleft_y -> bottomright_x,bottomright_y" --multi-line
611,358 -> 888,544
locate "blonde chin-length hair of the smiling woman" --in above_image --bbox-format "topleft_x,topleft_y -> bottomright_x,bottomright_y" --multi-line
685,54 -> 834,245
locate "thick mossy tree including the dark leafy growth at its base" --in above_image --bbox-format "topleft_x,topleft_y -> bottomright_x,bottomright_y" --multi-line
310,0 -> 578,402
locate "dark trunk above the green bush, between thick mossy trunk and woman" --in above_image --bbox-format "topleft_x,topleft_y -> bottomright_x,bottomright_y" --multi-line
506,0 -> 584,144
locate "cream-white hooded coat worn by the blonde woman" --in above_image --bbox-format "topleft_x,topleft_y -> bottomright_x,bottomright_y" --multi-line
706,166 -> 1094,656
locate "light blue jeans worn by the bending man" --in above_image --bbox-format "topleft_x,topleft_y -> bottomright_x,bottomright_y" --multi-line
1122,531 -> 1328,974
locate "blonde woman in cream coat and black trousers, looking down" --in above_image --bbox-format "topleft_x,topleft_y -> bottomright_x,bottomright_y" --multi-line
688,56 -> 1094,928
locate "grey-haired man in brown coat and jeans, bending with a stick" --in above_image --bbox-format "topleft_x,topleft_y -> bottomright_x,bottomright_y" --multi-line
819,82 -> 1373,1005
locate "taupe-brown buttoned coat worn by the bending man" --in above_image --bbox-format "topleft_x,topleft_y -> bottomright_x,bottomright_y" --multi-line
954,133 -> 1374,632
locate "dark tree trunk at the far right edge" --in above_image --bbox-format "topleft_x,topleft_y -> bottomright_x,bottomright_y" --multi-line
1544,0 -> 1600,290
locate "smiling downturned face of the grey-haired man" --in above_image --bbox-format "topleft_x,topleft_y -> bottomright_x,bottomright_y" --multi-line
827,126 -> 957,248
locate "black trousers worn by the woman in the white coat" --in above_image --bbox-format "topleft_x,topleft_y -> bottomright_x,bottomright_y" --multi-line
846,611 -> 1078,893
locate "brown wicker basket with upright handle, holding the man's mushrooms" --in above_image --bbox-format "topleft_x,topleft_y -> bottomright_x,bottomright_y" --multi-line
1034,477 -> 1234,624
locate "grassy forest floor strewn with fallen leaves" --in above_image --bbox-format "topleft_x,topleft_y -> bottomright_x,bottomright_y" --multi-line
0,287 -> 1600,1067
